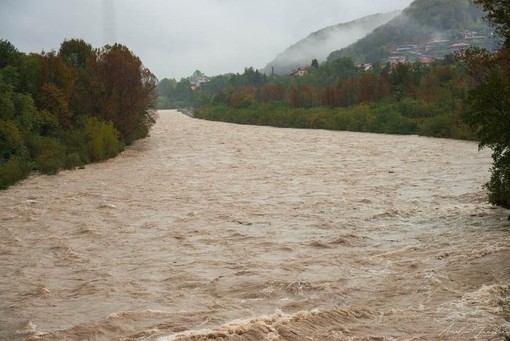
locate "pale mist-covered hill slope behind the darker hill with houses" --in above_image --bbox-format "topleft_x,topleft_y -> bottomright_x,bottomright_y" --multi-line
261,11 -> 401,75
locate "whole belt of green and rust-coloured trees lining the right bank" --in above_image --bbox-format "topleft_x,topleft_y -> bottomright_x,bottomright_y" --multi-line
191,56 -> 473,139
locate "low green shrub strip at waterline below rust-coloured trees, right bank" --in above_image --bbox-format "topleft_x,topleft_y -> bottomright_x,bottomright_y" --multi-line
194,99 -> 475,140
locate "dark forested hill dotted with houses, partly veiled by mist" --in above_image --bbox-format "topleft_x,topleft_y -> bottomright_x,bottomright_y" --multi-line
328,0 -> 496,63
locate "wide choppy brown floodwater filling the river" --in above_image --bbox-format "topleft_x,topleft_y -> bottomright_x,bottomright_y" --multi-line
0,111 -> 510,341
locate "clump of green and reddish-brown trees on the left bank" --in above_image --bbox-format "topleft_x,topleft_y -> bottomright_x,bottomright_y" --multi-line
0,39 -> 157,189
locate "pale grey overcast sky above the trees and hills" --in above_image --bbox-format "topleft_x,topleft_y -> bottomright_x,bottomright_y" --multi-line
0,0 -> 412,80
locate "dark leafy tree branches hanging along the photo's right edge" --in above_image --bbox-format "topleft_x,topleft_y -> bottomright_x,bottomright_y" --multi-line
466,0 -> 510,209
